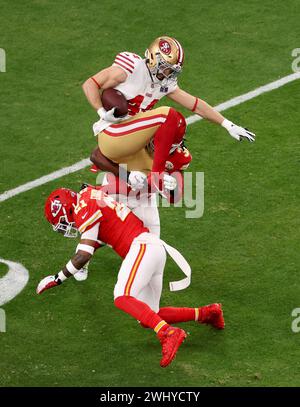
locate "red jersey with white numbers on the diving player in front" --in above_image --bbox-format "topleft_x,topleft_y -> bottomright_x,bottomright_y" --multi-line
74,187 -> 149,258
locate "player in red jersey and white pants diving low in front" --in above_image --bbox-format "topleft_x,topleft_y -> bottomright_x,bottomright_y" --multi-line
37,187 -> 224,367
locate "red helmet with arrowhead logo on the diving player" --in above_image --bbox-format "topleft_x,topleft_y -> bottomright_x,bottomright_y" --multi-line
45,188 -> 78,237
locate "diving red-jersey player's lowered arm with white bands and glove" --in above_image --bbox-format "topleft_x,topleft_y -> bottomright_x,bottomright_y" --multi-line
36,239 -> 99,294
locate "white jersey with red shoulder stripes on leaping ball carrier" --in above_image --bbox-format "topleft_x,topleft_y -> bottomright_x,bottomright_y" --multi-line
93,52 -> 177,136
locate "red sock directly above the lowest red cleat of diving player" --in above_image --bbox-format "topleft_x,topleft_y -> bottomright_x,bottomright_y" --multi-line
115,295 -> 169,333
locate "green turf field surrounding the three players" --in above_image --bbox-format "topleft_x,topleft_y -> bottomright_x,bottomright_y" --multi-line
0,0 -> 300,386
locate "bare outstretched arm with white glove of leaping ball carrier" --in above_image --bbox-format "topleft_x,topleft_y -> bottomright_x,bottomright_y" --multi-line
168,88 -> 255,142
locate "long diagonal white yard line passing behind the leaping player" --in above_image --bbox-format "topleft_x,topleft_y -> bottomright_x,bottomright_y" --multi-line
0,72 -> 300,202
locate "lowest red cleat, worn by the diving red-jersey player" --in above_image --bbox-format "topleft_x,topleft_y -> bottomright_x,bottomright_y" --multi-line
157,326 -> 186,367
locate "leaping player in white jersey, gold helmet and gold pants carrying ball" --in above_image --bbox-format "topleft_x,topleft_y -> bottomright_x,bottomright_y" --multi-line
83,36 -> 255,163
